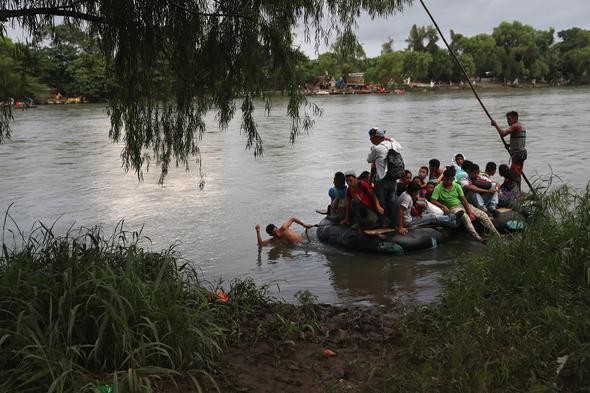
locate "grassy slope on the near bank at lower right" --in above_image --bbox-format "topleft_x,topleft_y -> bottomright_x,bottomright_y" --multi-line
381,187 -> 590,392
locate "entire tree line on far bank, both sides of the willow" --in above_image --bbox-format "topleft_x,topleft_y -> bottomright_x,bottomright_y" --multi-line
0,21 -> 590,101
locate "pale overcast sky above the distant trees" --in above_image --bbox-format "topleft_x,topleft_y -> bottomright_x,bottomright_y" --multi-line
301,0 -> 590,58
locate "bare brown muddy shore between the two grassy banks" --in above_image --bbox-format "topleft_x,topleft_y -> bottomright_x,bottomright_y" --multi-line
213,304 -> 399,393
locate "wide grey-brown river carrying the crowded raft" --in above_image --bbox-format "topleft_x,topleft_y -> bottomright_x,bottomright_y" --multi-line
0,87 -> 590,305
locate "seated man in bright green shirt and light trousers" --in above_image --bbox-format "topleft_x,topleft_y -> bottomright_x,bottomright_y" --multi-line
431,169 -> 500,241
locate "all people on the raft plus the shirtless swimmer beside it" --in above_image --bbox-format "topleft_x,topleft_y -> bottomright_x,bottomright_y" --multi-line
256,111 -> 527,246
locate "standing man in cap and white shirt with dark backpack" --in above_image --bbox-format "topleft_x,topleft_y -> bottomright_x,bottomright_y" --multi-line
367,127 -> 405,227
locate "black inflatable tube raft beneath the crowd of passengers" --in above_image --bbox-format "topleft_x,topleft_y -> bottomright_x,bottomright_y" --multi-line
317,209 -> 525,255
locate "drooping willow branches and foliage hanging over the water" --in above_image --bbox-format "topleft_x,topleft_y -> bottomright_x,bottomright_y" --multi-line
0,0 -> 412,181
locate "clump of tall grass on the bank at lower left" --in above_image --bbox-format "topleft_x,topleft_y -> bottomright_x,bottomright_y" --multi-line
0,220 -> 265,392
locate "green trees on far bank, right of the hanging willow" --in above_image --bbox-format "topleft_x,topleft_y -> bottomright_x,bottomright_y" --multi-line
301,21 -> 590,84
